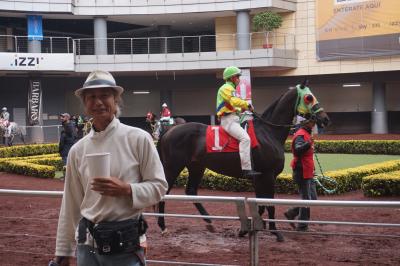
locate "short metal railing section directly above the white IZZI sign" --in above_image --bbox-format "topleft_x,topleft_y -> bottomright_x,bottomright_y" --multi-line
0,35 -> 74,54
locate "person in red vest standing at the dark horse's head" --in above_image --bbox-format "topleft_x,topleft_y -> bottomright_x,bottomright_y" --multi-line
284,115 -> 317,231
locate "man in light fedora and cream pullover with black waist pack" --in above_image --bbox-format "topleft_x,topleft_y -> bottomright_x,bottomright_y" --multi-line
49,70 -> 168,266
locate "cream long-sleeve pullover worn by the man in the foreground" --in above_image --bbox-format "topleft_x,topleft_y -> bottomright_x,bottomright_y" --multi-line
56,118 -> 168,256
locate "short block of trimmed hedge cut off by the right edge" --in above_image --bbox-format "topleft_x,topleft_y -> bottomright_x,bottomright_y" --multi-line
361,171 -> 400,197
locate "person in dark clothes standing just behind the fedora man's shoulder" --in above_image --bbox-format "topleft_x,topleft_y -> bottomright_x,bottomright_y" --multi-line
58,113 -> 76,165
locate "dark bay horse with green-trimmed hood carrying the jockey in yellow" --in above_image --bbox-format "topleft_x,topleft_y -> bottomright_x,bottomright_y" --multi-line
158,82 -> 329,241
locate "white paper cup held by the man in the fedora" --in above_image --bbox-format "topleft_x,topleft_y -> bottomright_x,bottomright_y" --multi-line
85,152 -> 111,178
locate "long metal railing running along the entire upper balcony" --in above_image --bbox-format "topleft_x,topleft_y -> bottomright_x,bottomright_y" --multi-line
0,32 -> 296,56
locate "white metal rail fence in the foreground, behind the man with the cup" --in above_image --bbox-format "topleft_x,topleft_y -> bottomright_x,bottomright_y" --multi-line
0,189 -> 400,266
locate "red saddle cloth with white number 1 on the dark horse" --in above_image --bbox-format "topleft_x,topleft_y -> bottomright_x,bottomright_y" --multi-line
206,120 -> 258,152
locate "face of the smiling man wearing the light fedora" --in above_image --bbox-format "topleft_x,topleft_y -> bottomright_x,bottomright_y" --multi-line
83,88 -> 117,120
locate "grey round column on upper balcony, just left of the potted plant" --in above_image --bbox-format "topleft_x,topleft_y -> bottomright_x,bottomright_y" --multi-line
236,10 -> 250,50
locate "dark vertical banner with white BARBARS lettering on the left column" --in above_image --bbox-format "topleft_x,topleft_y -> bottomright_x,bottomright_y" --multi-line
28,80 -> 42,126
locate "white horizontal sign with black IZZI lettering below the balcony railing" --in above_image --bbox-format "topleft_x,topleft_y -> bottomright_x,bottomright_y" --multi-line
0,53 -> 75,71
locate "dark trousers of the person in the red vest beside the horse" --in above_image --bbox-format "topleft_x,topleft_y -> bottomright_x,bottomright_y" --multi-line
286,169 -> 317,229
